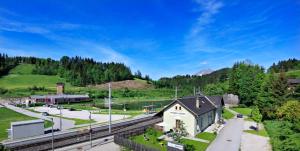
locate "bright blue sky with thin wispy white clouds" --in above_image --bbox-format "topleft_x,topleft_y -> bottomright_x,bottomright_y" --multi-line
0,0 -> 300,79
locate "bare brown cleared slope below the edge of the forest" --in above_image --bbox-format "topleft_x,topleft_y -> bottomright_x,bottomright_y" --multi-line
88,79 -> 153,89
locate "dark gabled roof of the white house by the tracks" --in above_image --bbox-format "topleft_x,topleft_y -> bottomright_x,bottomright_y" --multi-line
156,95 -> 224,116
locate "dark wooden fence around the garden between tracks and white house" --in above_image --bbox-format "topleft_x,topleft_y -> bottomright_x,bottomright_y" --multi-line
114,127 -> 159,151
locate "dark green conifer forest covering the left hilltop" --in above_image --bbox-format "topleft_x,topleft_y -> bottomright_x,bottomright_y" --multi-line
0,54 -> 136,86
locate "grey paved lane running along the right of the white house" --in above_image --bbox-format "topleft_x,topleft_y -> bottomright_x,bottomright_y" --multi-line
207,118 -> 244,151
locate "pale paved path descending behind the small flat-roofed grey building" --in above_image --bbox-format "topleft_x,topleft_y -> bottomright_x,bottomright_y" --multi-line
4,104 -> 75,130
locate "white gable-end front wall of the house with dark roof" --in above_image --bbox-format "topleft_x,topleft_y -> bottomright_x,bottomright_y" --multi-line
163,103 -> 196,136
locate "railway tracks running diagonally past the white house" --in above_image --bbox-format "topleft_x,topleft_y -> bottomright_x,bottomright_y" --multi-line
2,116 -> 162,151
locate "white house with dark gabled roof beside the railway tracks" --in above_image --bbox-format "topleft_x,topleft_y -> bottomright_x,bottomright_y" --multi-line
157,94 -> 224,136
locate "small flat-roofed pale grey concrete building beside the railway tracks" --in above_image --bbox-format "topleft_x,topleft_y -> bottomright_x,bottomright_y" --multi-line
10,120 -> 44,139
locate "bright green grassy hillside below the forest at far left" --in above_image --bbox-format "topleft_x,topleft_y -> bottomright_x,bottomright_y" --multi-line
0,64 -> 72,89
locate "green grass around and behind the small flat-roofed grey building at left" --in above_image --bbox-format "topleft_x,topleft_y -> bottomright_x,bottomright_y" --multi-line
0,107 -> 53,141
